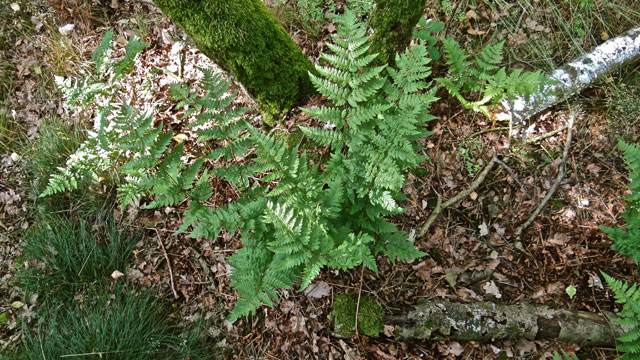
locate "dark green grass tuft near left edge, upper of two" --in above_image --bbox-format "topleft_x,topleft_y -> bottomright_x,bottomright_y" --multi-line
17,217 -> 139,299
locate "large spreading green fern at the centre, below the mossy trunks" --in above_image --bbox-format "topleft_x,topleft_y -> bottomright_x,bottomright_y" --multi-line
43,11 -> 436,320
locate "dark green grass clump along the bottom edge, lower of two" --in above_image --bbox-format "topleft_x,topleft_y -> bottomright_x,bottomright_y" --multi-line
23,287 -> 211,360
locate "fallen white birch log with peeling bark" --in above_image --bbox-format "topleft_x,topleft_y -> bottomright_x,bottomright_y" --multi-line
493,27 -> 640,125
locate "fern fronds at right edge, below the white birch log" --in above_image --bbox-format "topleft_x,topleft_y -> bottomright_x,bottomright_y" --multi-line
601,140 -> 640,264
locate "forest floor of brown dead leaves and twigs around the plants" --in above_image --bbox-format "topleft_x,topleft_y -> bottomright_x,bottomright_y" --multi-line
0,0 -> 640,359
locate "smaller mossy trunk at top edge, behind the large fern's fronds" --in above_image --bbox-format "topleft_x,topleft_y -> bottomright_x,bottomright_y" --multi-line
369,0 -> 426,64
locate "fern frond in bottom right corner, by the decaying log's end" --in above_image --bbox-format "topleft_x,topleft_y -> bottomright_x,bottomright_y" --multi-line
602,272 -> 640,360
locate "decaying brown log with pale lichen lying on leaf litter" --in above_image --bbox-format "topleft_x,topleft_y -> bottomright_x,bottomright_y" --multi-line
383,300 -> 628,347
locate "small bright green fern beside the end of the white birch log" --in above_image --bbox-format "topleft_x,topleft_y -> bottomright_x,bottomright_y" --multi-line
436,37 -> 548,117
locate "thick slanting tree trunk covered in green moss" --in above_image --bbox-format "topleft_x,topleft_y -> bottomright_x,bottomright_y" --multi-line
154,0 -> 314,124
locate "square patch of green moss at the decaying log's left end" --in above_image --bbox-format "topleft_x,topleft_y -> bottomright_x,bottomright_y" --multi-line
331,294 -> 384,337
